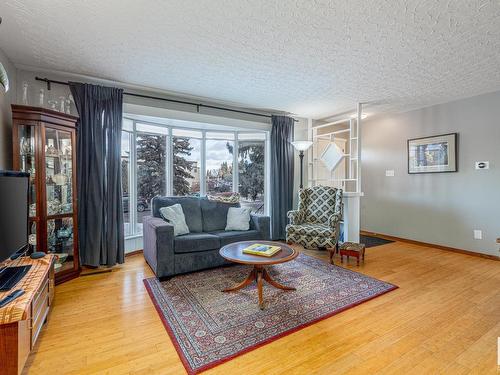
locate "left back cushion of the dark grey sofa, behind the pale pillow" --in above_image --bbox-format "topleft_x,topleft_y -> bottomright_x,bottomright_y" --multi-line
151,196 -> 203,233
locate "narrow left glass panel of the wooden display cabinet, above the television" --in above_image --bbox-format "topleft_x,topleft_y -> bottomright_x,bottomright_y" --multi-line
17,125 -> 38,218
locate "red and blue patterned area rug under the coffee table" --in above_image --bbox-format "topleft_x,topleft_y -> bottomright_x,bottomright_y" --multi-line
144,254 -> 397,374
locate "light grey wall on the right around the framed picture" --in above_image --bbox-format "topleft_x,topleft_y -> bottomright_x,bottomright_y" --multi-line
361,92 -> 500,256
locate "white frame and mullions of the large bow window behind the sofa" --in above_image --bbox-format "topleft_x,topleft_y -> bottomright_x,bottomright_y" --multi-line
122,119 -> 271,239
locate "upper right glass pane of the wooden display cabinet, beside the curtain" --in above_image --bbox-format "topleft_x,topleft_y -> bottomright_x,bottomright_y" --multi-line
45,128 -> 73,216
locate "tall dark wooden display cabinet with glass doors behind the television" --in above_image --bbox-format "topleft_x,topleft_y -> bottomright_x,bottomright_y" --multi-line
12,105 -> 80,284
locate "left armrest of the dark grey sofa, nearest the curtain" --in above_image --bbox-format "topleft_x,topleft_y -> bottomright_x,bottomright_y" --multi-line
142,216 -> 174,277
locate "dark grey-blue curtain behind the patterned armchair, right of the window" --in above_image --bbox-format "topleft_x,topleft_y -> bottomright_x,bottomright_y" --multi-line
271,116 -> 294,240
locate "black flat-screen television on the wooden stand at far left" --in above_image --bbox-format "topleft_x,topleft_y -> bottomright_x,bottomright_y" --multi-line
0,171 -> 29,291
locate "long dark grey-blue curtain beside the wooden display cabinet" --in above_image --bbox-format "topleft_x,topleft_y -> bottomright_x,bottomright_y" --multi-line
70,82 -> 124,267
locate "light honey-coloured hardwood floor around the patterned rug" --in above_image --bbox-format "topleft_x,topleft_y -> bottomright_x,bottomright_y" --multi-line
24,242 -> 500,375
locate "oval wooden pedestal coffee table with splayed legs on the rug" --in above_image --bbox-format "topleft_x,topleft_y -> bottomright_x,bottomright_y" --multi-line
219,241 -> 299,309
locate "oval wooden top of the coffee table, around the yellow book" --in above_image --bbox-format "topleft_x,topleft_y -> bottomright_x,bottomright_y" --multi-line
219,241 -> 299,266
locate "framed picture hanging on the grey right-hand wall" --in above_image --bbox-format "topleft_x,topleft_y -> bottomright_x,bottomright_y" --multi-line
408,133 -> 458,174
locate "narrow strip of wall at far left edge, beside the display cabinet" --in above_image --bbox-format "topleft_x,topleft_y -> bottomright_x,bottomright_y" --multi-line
0,49 -> 16,169
